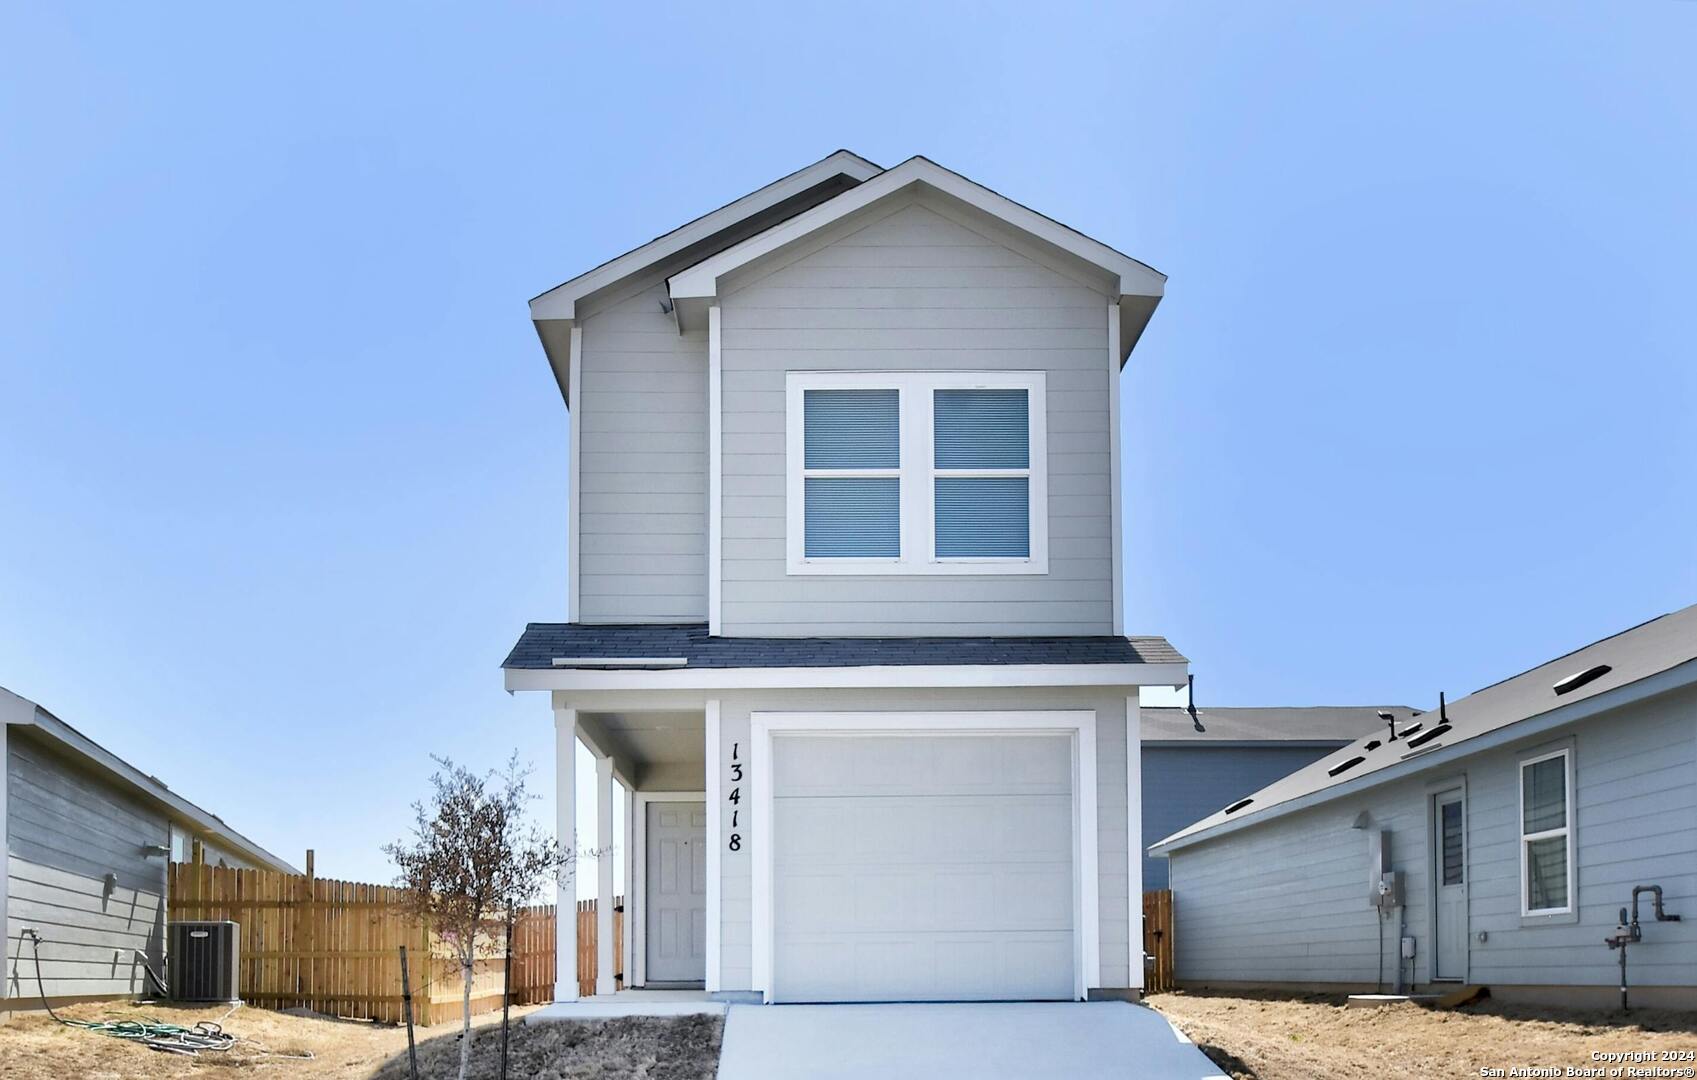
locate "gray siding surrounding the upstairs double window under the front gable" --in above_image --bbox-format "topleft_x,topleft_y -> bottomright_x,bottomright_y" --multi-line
721,196 -> 1113,637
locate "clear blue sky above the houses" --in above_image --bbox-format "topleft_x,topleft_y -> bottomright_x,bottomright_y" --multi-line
0,0 -> 1697,880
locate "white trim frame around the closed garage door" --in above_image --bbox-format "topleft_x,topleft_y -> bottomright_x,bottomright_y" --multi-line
745,710 -> 1092,1005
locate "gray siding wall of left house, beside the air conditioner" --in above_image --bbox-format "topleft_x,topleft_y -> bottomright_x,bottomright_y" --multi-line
5,728 -> 170,997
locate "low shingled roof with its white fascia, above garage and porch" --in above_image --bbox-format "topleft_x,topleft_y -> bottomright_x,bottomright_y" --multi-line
502,623 -> 1188,689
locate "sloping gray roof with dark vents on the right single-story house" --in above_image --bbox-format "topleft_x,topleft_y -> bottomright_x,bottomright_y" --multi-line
1151,606 -> 1697,854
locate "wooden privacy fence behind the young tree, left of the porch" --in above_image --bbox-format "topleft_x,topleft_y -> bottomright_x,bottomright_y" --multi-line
166,858 -> 623,1024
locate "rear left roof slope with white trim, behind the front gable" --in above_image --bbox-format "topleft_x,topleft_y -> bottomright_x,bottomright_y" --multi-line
529,149 -> 882,397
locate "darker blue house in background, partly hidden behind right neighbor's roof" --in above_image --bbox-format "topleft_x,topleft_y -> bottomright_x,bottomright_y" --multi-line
1142,705 -> 1417,888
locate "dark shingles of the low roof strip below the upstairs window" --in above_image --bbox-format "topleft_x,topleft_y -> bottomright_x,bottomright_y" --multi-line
501,623 -> 1186,671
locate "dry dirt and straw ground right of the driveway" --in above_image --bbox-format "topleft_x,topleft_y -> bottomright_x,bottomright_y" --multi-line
1149,992 -> 1697,1080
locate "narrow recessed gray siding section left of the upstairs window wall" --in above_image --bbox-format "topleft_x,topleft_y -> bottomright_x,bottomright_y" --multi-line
572,285 -> 708,623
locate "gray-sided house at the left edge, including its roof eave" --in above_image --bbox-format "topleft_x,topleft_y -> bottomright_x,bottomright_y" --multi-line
0,689 -> 299,1014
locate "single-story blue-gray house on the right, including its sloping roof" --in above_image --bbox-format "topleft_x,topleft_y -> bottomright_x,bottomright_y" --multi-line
1154,606 -> 1697,1009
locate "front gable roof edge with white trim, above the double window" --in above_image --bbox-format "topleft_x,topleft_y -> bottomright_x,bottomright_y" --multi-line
667,156 -> 1166,363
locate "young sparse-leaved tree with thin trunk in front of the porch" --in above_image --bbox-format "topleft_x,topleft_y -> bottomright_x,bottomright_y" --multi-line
384,752 -> 574,1080
